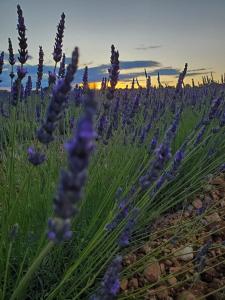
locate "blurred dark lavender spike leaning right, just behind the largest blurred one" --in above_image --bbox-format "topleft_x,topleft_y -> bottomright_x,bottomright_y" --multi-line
37,48 -> 79,145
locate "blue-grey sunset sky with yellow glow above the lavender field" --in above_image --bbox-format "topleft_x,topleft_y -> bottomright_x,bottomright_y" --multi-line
0,0 -> 225,87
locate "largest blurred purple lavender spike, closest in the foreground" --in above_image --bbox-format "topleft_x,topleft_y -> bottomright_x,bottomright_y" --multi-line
48,91 -> 96,242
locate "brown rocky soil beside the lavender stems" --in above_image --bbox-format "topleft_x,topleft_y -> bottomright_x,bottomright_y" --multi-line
119,174 -> 225,300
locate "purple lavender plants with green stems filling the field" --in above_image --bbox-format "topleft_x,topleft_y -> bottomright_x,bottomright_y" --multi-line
0,6 -> 225,299
